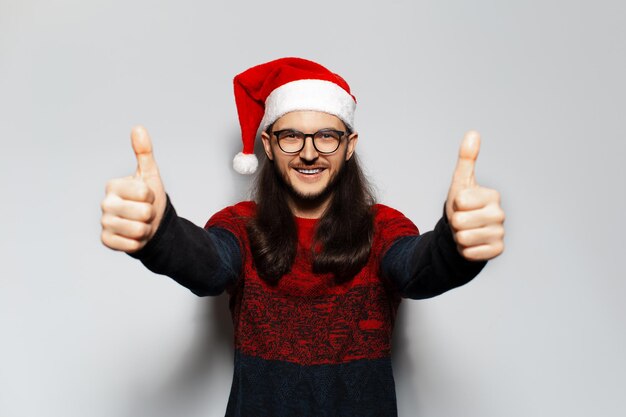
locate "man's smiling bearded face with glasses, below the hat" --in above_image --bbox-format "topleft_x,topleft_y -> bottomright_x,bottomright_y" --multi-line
261,110 -> 358,217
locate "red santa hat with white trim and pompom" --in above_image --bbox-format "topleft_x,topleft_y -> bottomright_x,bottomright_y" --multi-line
233,58 -> 356,174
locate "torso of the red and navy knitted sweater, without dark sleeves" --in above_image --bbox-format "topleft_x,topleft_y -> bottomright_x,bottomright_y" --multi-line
205,202 -> 419,416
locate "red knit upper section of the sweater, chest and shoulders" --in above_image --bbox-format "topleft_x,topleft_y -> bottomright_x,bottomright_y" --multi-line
205,201 -> 419,365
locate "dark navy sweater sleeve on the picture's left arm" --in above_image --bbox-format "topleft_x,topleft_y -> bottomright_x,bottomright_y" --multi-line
128,194 -> 242,296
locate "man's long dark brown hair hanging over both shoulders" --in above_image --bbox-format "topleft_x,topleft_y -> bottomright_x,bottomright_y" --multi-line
247,126 -> 375,284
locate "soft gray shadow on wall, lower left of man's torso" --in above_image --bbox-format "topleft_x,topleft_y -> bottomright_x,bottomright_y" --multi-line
126,293 -> 234,417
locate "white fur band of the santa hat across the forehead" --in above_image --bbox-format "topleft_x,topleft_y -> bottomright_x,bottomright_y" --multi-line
261,79 -> 356,130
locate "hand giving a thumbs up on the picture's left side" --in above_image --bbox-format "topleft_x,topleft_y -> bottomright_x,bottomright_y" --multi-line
101,126 -> 167,253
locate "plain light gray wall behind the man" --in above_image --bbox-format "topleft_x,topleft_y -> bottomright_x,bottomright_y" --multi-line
0,0 -> 626,417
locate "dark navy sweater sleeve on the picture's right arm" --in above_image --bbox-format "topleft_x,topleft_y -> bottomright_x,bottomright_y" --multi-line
381,204 -> 487,299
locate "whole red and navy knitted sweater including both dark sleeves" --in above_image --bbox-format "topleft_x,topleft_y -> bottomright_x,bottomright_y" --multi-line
130,195 -> 486,417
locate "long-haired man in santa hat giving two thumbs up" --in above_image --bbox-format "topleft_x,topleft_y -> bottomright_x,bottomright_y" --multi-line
102,58 -> 504,417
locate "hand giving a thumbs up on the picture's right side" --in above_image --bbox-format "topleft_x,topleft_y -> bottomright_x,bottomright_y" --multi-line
446,131 -> 505,261
